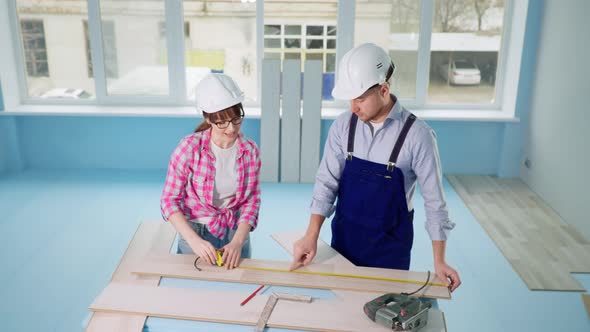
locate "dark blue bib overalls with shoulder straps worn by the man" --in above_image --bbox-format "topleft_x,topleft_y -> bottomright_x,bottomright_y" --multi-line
332,114 -> 416,270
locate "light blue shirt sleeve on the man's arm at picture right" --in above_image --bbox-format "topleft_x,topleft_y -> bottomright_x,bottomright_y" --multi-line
412,127 -> 455,241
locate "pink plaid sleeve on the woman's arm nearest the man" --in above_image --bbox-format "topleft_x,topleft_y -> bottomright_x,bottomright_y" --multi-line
238,146 -> 261,230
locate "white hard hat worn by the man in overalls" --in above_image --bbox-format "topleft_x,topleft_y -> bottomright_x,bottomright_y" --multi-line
332,43 -> 395,100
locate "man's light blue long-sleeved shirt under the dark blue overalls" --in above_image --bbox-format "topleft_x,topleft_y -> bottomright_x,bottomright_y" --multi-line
311,102 -> 455,241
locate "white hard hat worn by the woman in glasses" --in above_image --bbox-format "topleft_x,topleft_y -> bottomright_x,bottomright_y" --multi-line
195,74 -> 244,113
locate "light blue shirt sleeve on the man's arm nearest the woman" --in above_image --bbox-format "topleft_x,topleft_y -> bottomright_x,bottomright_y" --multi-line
310,114 -> 350,218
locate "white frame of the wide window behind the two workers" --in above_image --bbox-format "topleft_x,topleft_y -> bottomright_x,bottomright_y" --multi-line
0,0 -> 530,121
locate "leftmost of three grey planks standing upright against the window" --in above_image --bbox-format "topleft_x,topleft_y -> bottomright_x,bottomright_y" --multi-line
260,59 -> 281,182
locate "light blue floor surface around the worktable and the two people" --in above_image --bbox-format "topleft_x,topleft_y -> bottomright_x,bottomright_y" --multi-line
0,171 -> 590,332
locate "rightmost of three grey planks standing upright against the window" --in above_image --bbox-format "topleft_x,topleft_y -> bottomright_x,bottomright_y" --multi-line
299,60 -> 322,183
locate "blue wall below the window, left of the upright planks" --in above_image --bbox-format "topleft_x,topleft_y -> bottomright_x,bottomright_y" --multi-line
18,116 -> 260,169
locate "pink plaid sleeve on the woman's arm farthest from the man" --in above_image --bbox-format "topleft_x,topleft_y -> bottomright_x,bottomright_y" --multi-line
160,138 -> 193,220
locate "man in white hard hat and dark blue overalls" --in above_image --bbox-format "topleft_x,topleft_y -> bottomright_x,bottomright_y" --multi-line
291,43 -> 461,291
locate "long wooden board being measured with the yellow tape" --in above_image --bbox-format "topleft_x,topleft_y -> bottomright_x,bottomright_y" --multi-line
133,255 -> 450,299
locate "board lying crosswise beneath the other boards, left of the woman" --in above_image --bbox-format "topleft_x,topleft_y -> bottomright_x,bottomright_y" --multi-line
86,222 -> 176,332
